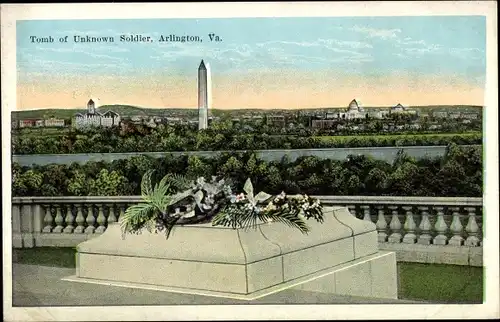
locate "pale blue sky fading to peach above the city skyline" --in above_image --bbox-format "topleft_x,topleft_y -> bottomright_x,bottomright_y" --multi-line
16,16 -> 486,110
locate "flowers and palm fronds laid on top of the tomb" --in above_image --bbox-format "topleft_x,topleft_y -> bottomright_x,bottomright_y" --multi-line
120,171 -> 323,238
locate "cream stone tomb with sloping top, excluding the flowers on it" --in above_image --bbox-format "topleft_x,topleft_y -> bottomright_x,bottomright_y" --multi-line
65,207 -> 397,300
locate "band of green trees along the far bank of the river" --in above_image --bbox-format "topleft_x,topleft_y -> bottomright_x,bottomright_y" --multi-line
12,122 -> 482,154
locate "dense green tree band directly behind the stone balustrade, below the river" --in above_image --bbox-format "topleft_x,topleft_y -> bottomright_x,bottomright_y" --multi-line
12,144 -> 483,197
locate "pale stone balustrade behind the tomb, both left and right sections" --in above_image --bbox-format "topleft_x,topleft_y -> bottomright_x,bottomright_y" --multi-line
12,196 -> 483,266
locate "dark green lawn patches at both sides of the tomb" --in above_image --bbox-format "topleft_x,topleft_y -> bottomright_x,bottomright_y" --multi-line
13,247 -> 483,304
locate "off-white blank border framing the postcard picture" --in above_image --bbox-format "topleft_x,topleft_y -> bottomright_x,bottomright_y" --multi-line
1,1 -> 500,321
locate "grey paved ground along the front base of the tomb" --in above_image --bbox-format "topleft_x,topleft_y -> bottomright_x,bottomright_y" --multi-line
12,264 -> 421,307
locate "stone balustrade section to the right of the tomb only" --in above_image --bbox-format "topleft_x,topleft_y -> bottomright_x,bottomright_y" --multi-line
318,196 -> 483,266
